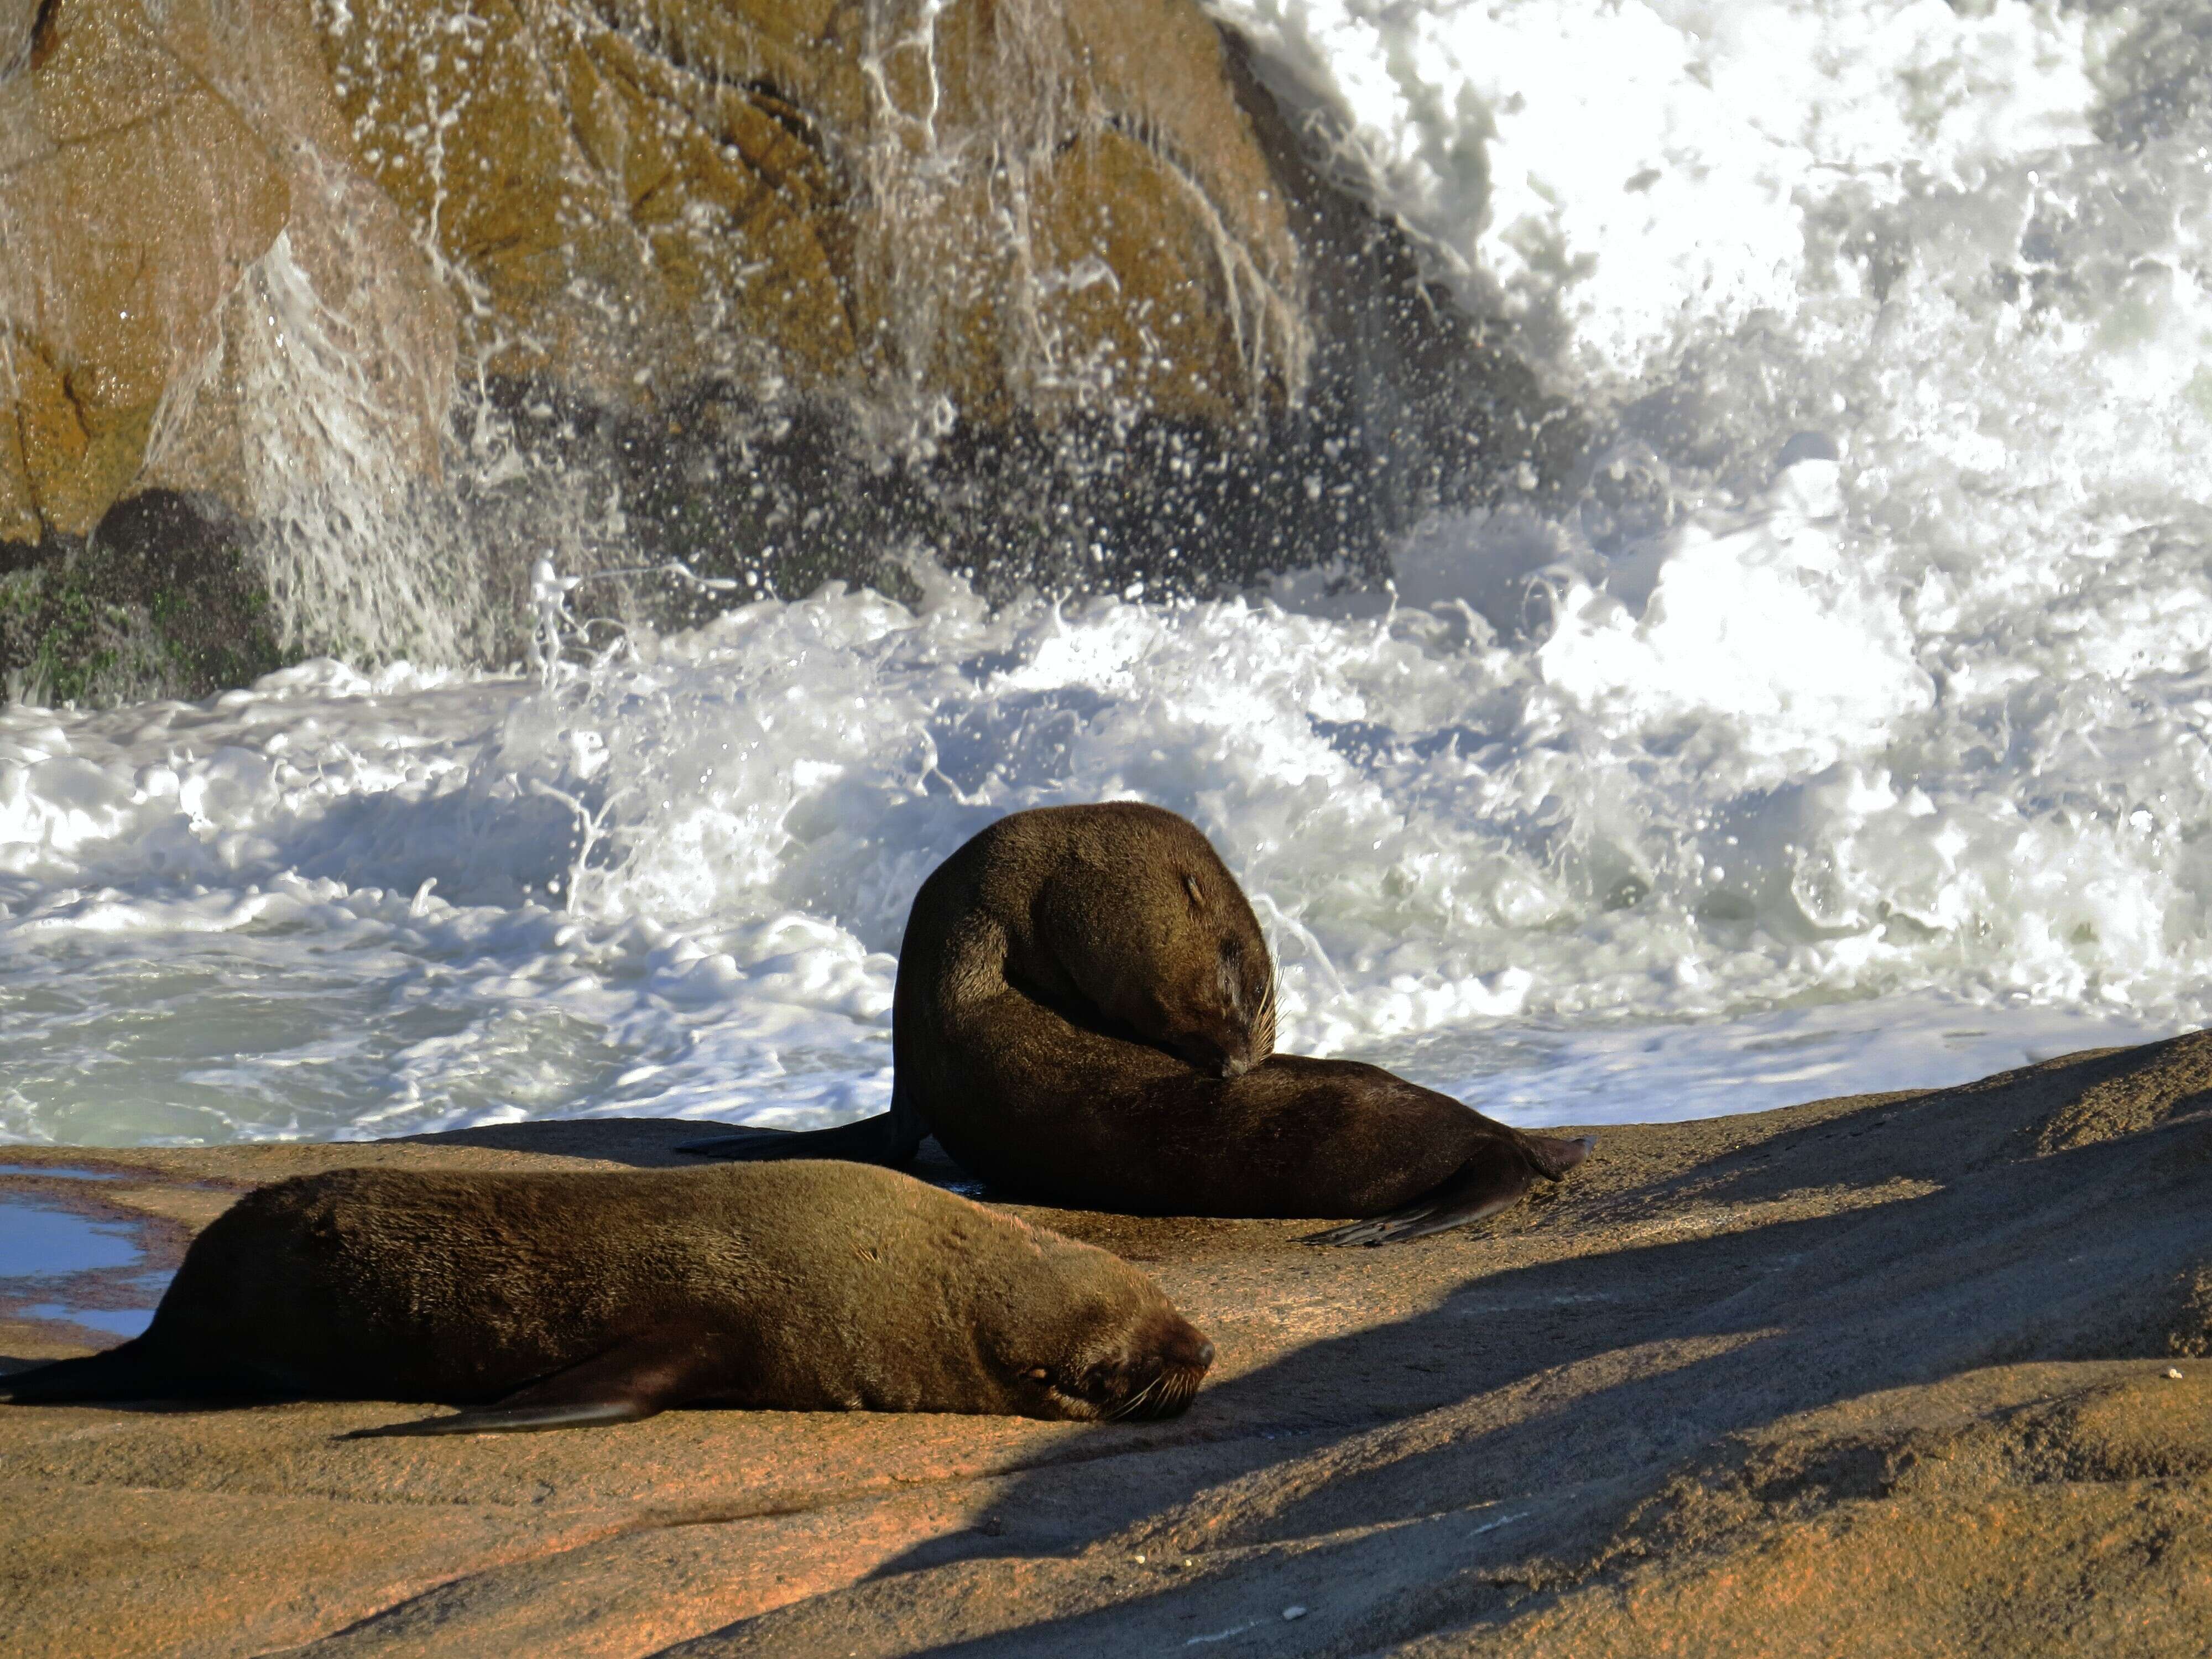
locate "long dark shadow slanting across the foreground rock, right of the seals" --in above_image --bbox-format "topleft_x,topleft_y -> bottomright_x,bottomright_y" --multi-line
664,1035 -> 2212,1657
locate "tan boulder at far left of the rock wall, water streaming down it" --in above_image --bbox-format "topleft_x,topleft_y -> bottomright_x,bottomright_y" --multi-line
0,0 -> 451,540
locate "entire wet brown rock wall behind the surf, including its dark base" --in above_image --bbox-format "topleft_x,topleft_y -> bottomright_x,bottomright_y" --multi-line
0,0 -> 1577,690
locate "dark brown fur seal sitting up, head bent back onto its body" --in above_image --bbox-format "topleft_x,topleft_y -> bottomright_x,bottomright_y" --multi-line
684,801 -> 1590,1243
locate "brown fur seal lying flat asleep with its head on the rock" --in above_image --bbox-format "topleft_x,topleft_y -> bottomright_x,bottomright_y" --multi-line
0,1164 -> 1214,1436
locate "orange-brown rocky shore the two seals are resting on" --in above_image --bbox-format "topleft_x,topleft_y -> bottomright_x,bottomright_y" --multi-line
0,1033 -> 2212,1659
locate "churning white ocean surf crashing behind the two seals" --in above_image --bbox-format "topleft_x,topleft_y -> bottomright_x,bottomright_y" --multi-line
0,0 -> 2212,1144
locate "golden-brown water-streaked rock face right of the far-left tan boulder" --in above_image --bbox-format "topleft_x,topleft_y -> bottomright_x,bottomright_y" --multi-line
319,0 -> 1305,436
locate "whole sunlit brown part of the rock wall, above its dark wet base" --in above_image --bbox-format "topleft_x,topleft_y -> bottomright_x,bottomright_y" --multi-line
0,0 -> 1310,542
